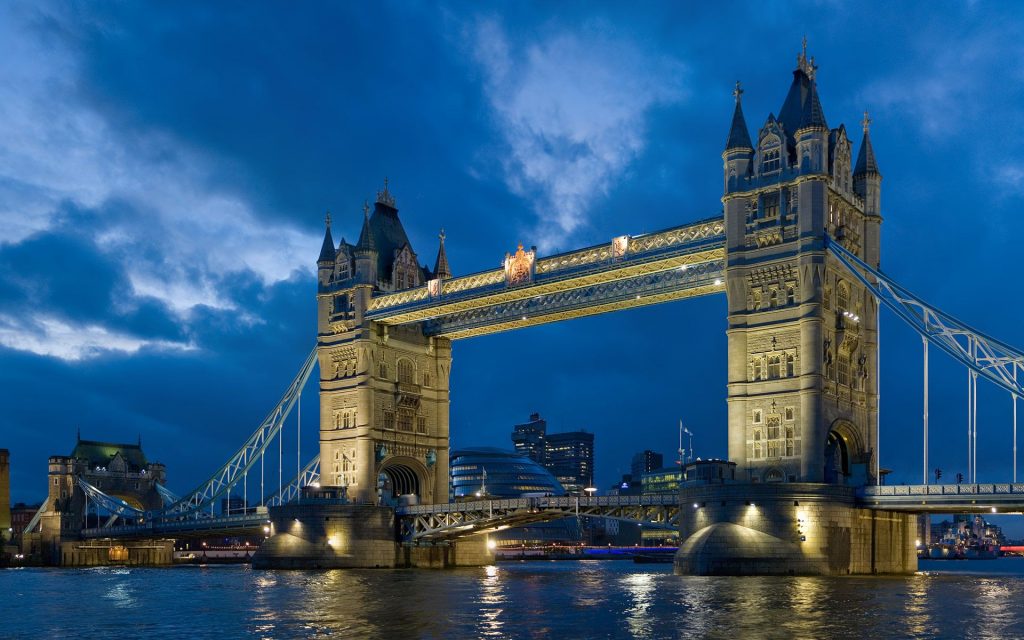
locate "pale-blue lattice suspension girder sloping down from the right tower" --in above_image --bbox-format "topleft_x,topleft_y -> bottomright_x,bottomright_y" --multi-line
826,238 -> 1024,397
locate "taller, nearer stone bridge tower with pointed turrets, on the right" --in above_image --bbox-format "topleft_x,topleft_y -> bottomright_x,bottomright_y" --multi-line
722,45 -> 882,484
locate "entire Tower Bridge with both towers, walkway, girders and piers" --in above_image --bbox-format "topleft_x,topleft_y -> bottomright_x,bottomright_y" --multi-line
25,45 -> 1024,573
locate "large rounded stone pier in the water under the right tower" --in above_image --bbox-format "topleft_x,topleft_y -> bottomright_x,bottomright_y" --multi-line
675,483 -> 918,575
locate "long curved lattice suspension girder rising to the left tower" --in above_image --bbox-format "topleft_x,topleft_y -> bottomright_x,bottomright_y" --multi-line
154,348 -> 316,518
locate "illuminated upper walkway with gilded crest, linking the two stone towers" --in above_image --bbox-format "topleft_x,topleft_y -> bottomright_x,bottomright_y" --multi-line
367,216 -> 725,339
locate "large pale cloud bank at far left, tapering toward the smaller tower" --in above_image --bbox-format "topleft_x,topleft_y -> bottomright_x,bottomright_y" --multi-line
0,5 -> 319,359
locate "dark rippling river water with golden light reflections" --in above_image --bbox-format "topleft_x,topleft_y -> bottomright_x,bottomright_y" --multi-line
0,558 -> 1024,640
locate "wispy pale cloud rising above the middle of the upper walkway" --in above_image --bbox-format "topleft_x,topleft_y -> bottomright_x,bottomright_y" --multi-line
472,20 -> 685,250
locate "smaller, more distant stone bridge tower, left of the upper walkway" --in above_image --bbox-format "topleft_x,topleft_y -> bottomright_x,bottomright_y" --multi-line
316,180 -> 452,503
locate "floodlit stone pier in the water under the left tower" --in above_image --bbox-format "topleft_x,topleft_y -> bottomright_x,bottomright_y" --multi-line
253,503 -> 495,568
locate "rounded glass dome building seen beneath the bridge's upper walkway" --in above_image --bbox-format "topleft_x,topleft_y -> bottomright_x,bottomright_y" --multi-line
450,446 -> 565,500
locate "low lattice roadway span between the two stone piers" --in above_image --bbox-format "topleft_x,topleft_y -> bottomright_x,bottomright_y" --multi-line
397,495 -> 680,542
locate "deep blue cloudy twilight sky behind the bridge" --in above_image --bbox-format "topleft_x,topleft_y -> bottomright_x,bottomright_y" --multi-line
0,1 -> 1024,522
